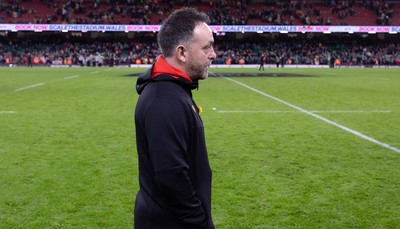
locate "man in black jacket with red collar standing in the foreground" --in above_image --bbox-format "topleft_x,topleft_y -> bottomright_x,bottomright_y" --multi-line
134,8 -> 216,229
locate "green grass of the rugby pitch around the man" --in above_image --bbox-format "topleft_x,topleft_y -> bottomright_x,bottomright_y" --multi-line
0,68 -> 400,229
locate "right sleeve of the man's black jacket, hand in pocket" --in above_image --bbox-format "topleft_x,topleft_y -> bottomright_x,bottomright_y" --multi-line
145,96 -> 206,227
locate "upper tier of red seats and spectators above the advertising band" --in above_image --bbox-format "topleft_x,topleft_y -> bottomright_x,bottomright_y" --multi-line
0,0 -> 400,25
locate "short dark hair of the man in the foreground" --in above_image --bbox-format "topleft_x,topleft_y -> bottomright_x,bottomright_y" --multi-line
157,7 -> 210,57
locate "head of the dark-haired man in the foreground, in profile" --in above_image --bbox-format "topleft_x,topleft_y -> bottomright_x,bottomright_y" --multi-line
157,8 -> 216,80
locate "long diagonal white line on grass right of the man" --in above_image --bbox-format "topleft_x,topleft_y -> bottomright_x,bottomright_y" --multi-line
223,77 -> 400,153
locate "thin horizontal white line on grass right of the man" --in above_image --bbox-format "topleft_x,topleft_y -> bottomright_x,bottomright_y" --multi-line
213,108 -> 392,114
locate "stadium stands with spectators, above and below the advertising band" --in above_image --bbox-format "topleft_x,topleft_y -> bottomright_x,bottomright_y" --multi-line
0,0 -> 400,66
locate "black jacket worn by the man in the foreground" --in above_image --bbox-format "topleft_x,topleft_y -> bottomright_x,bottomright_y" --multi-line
134,65 -> 214,229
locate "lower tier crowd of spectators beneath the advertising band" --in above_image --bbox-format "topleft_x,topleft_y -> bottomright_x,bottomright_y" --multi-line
0,34 -> 400,66
